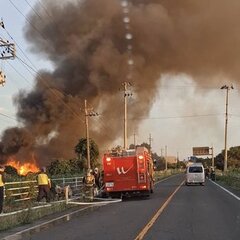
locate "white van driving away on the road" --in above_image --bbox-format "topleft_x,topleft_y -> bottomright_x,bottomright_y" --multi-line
186,163 -> 205,185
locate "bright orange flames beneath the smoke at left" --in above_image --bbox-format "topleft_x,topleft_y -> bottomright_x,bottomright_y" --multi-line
6,158 -> 39,176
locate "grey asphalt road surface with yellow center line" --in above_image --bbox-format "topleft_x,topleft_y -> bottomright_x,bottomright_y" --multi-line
29,175 -> 240,240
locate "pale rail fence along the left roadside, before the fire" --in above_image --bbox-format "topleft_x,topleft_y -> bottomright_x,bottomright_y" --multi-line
5,177 -> 83,202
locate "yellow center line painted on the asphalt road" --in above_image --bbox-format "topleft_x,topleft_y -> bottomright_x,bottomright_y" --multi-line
134,180 -> 185,240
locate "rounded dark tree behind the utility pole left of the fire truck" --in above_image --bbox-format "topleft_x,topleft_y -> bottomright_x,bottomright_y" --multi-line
74,138 -> 100,169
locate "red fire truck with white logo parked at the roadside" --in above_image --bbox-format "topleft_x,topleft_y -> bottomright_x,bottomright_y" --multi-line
103,147 -> 154,197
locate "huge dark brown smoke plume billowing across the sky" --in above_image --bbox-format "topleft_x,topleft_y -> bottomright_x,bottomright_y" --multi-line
0,0 -> 240,163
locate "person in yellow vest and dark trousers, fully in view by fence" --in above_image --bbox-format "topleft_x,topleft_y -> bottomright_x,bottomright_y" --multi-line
37,167 -> 51,202
